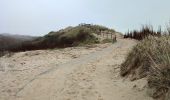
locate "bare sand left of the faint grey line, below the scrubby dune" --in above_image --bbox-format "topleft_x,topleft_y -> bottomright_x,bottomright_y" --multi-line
0,44 -> 111,100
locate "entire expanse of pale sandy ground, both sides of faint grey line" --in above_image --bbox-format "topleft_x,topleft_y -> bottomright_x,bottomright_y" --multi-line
0,39 -> 152,100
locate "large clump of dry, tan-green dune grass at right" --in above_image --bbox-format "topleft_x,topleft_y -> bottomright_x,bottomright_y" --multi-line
121,36 -> 170,100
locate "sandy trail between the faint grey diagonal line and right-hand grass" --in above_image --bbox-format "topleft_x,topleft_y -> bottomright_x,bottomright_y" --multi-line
12,39 -> 152,100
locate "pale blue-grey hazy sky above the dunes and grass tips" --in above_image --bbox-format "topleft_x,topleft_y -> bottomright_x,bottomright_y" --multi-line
0,0 -> 170,36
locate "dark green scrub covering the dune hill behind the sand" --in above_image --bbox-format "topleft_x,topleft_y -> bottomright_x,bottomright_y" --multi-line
0,24 -> 115,52
